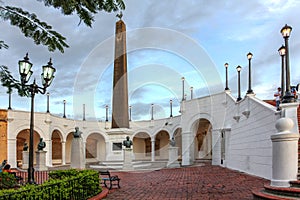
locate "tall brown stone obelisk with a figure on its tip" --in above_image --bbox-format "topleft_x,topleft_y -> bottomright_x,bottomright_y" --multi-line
111,13 -> 129,129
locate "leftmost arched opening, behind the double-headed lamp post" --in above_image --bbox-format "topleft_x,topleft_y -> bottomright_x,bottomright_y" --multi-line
16,129 -> 40,167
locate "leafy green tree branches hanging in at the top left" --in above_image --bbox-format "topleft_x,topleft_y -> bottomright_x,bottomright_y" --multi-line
0,0 -> 125,96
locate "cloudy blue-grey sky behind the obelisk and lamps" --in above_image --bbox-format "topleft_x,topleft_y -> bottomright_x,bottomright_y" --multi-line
0,0 -> 300,120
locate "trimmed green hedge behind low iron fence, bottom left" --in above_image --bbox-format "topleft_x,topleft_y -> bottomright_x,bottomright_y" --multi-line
0,169 -> 102,200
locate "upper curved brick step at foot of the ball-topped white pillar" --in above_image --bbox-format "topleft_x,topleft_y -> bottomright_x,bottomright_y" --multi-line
264,185 -> 300,199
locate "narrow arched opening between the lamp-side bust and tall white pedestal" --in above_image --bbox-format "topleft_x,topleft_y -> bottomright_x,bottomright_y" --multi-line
51,130 -> 62,165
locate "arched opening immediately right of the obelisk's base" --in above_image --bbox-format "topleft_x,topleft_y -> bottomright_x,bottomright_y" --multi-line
132,132 -> 151,160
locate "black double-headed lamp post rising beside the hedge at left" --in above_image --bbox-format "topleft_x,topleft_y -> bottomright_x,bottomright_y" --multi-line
19,53 -> 56,184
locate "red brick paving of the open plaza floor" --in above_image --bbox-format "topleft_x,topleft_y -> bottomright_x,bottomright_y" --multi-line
106,164 -> 269,200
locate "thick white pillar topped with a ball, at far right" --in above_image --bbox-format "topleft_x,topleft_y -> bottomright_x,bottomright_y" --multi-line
271,118 -> 299,187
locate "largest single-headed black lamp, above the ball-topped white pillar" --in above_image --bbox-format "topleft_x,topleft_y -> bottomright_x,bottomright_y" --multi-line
280,24 -> 295,103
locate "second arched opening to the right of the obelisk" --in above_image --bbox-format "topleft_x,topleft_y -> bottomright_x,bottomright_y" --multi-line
155,130 -> 170,159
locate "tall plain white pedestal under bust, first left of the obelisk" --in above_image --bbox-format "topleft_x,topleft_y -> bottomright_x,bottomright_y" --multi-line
71,138 -> 85,169
